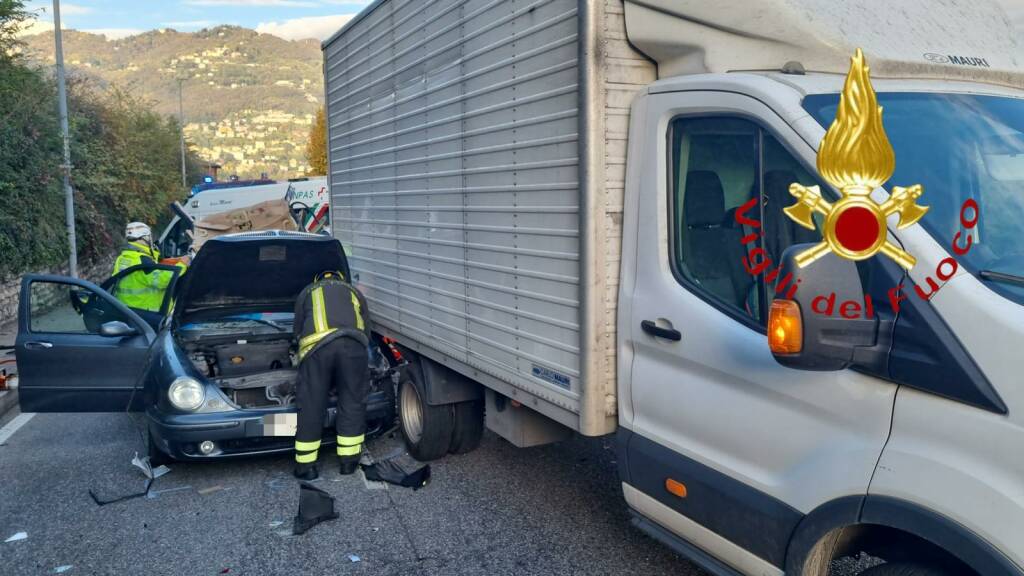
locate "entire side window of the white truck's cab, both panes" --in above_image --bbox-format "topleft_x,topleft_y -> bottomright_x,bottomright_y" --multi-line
670,118 -> 821,326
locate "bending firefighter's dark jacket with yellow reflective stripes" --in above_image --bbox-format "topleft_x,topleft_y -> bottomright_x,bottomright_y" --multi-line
294,279 -> 370,362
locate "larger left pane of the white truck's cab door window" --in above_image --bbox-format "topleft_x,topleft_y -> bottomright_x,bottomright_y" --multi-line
670,118 -> 761,322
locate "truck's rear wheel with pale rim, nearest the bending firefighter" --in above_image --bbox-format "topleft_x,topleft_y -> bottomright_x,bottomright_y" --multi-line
398,364 -> 453,461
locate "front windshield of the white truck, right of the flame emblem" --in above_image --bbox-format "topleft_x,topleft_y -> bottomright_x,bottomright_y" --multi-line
804,92 -> 1024,303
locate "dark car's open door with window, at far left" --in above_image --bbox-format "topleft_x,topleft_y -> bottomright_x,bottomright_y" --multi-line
14,264 -> 180,412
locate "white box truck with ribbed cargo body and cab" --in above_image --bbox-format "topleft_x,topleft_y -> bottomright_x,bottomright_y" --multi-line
323,0 -> 1024,576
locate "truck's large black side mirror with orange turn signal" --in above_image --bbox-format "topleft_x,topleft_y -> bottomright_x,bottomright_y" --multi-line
768,244 -> 879,371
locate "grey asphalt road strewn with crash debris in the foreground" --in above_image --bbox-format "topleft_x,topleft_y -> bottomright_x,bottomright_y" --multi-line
0,411 -> 701,576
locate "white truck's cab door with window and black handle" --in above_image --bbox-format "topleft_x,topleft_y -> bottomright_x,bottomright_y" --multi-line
623,92 -> 896,573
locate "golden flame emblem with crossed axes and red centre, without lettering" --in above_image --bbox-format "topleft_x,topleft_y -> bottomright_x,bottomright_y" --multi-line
784,48 -> 928,270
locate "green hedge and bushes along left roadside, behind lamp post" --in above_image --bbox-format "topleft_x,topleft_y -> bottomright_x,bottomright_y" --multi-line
0,0 -> 200,279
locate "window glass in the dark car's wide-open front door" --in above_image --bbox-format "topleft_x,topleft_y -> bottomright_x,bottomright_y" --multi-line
29,280 -> 130,334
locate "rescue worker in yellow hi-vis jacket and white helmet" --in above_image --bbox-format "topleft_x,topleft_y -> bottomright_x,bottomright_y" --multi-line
111,222 -> 185,323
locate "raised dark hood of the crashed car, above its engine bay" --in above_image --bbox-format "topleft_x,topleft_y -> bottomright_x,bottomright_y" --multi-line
174,231 -> 349,316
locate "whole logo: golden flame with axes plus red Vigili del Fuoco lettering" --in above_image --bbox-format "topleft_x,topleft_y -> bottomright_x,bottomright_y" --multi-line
735,48 -> 979,319
